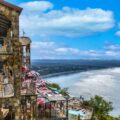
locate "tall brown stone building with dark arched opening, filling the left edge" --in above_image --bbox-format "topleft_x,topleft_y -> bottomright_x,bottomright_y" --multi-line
0,0 -> 35,120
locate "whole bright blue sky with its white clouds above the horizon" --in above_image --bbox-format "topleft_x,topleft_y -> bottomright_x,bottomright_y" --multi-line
7,0 -> 120,60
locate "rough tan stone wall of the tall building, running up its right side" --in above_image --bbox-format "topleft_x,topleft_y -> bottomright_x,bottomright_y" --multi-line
0,4 -> 22,120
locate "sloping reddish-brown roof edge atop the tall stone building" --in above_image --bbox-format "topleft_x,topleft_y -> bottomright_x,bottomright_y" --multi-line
0,0 -> 22,13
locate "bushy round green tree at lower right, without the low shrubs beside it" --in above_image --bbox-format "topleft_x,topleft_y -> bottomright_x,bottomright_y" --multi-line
89,95 -> 113,120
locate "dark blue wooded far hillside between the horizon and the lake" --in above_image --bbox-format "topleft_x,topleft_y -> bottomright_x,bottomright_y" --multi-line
32,60 -> 120,77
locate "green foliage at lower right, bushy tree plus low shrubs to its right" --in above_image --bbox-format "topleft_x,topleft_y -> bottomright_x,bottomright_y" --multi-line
83,95 -> 120,120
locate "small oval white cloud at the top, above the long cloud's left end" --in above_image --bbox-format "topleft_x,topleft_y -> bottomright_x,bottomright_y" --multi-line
19,1 -> 53,12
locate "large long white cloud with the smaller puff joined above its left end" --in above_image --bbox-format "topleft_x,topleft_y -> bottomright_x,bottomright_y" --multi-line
20,1 -> 114,37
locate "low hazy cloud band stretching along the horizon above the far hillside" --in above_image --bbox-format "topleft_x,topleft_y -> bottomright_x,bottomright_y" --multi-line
32,41 -> 120,59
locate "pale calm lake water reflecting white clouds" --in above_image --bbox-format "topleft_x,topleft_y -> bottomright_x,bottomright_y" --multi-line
47,68 -> 120,115
